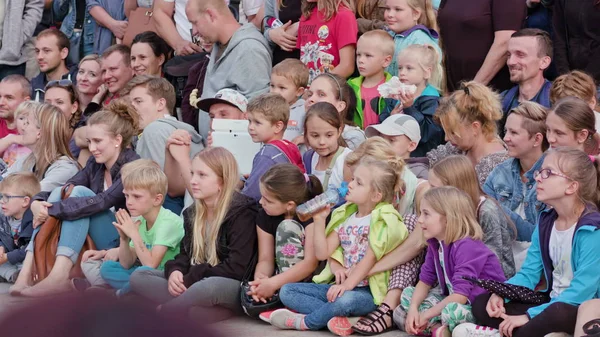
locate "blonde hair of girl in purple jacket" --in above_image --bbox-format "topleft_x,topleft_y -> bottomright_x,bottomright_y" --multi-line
423,186 -> 483,244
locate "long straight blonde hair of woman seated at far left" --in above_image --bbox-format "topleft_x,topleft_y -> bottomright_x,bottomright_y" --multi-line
23,103 -> 76,180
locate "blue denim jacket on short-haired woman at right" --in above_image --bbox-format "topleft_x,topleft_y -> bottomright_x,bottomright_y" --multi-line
483,155 -> 546,241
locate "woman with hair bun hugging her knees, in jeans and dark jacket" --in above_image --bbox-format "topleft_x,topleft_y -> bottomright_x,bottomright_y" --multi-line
11,101 -> 139,296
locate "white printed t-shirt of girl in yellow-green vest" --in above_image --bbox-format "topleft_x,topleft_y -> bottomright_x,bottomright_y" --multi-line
336,213 -> 371,287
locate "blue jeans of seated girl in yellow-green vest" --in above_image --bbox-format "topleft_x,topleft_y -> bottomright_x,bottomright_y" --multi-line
279,283 -> 377,330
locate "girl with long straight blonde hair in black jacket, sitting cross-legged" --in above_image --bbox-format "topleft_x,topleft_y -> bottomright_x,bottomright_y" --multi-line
130,147 -> 257,312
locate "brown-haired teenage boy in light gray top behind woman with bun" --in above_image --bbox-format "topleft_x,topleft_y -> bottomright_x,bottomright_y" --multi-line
128,75 -> 204,214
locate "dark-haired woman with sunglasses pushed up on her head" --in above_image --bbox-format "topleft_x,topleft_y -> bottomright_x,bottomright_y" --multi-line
44,80 -> 90,166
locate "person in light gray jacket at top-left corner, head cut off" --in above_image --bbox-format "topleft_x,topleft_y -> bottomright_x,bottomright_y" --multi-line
0,0 -> 44,80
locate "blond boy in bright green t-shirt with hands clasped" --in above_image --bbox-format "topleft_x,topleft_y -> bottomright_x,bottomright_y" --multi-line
82,159 -> 184,296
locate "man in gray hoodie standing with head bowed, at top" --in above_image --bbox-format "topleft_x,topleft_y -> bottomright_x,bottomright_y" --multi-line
186,0 -> 272,138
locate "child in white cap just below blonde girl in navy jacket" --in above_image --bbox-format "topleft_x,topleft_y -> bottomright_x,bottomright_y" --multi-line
365,114 -> 429,180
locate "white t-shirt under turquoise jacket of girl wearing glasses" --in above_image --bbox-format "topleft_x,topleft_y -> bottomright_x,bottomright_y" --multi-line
550,223 -> 577,298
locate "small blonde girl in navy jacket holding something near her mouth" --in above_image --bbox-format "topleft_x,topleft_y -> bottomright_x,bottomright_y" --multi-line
392,44 -> 444,157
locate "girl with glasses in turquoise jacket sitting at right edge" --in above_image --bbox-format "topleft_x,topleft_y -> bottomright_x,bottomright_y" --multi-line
454,148 -> 600,337
